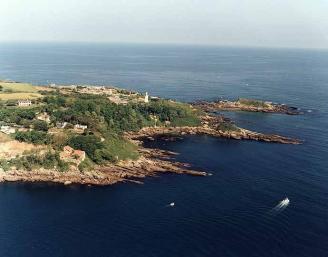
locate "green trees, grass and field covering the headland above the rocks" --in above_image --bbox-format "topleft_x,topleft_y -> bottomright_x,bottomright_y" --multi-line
0,82 -> 201,171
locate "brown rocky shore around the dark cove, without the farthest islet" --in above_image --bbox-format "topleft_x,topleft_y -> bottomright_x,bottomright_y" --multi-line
0,119 -> 301,186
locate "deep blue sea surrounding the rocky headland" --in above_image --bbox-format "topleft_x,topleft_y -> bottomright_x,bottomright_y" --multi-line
0,44 -> 328,257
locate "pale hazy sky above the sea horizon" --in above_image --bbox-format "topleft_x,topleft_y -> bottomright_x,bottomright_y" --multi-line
0,0 -> 328,48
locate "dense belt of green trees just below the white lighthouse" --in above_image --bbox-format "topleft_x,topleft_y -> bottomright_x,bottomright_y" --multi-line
44,95 -> 200,133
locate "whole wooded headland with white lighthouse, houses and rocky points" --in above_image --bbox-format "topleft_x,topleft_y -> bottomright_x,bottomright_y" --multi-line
0,81 -> 301,185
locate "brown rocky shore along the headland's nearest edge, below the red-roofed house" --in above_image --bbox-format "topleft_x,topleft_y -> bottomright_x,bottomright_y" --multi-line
0,142 -> 208,186
